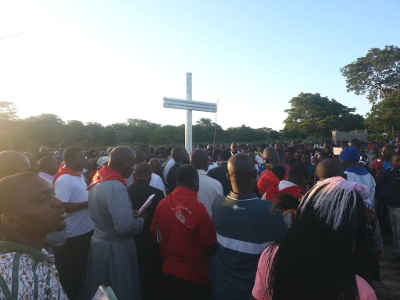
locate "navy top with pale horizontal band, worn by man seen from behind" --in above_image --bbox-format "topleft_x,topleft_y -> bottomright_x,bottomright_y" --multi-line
213,193 -> 287,300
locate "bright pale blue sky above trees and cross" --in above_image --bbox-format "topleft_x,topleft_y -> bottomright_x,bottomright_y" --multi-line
0,0 -> 400,130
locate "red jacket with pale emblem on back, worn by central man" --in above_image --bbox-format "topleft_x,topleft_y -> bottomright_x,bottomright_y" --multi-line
151,186 -> 217,283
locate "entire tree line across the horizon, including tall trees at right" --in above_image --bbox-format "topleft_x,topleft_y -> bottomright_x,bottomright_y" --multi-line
0,46 -> 400,150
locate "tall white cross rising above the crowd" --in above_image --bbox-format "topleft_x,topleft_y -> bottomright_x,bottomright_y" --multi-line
164,73 -> 217,154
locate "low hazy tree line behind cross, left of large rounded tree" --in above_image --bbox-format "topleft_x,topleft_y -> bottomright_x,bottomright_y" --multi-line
0,104 -> 279,151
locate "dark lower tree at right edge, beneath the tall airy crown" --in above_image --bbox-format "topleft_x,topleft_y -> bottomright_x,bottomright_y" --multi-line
365,89 -> 400,133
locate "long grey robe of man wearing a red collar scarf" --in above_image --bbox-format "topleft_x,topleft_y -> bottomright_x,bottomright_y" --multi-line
88,180 -> 143,300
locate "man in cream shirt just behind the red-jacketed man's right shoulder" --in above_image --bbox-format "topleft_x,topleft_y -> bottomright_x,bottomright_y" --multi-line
191,150 -> 224,217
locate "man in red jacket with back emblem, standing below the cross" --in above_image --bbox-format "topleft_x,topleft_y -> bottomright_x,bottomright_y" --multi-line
151,166 -> 217,300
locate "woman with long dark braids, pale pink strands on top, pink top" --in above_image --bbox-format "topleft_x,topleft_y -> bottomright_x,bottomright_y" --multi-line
253,177 -> 376,300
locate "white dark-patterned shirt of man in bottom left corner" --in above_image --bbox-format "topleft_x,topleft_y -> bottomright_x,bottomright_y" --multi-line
0,241 -> 68,300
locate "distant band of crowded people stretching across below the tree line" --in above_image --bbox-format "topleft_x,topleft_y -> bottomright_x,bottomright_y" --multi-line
0,140 -> 400,210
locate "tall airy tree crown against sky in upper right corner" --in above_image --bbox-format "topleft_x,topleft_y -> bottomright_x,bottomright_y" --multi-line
341,46 -> 400,103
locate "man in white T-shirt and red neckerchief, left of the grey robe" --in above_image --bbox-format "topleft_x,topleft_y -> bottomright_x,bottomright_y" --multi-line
53,148 -> 94,299
